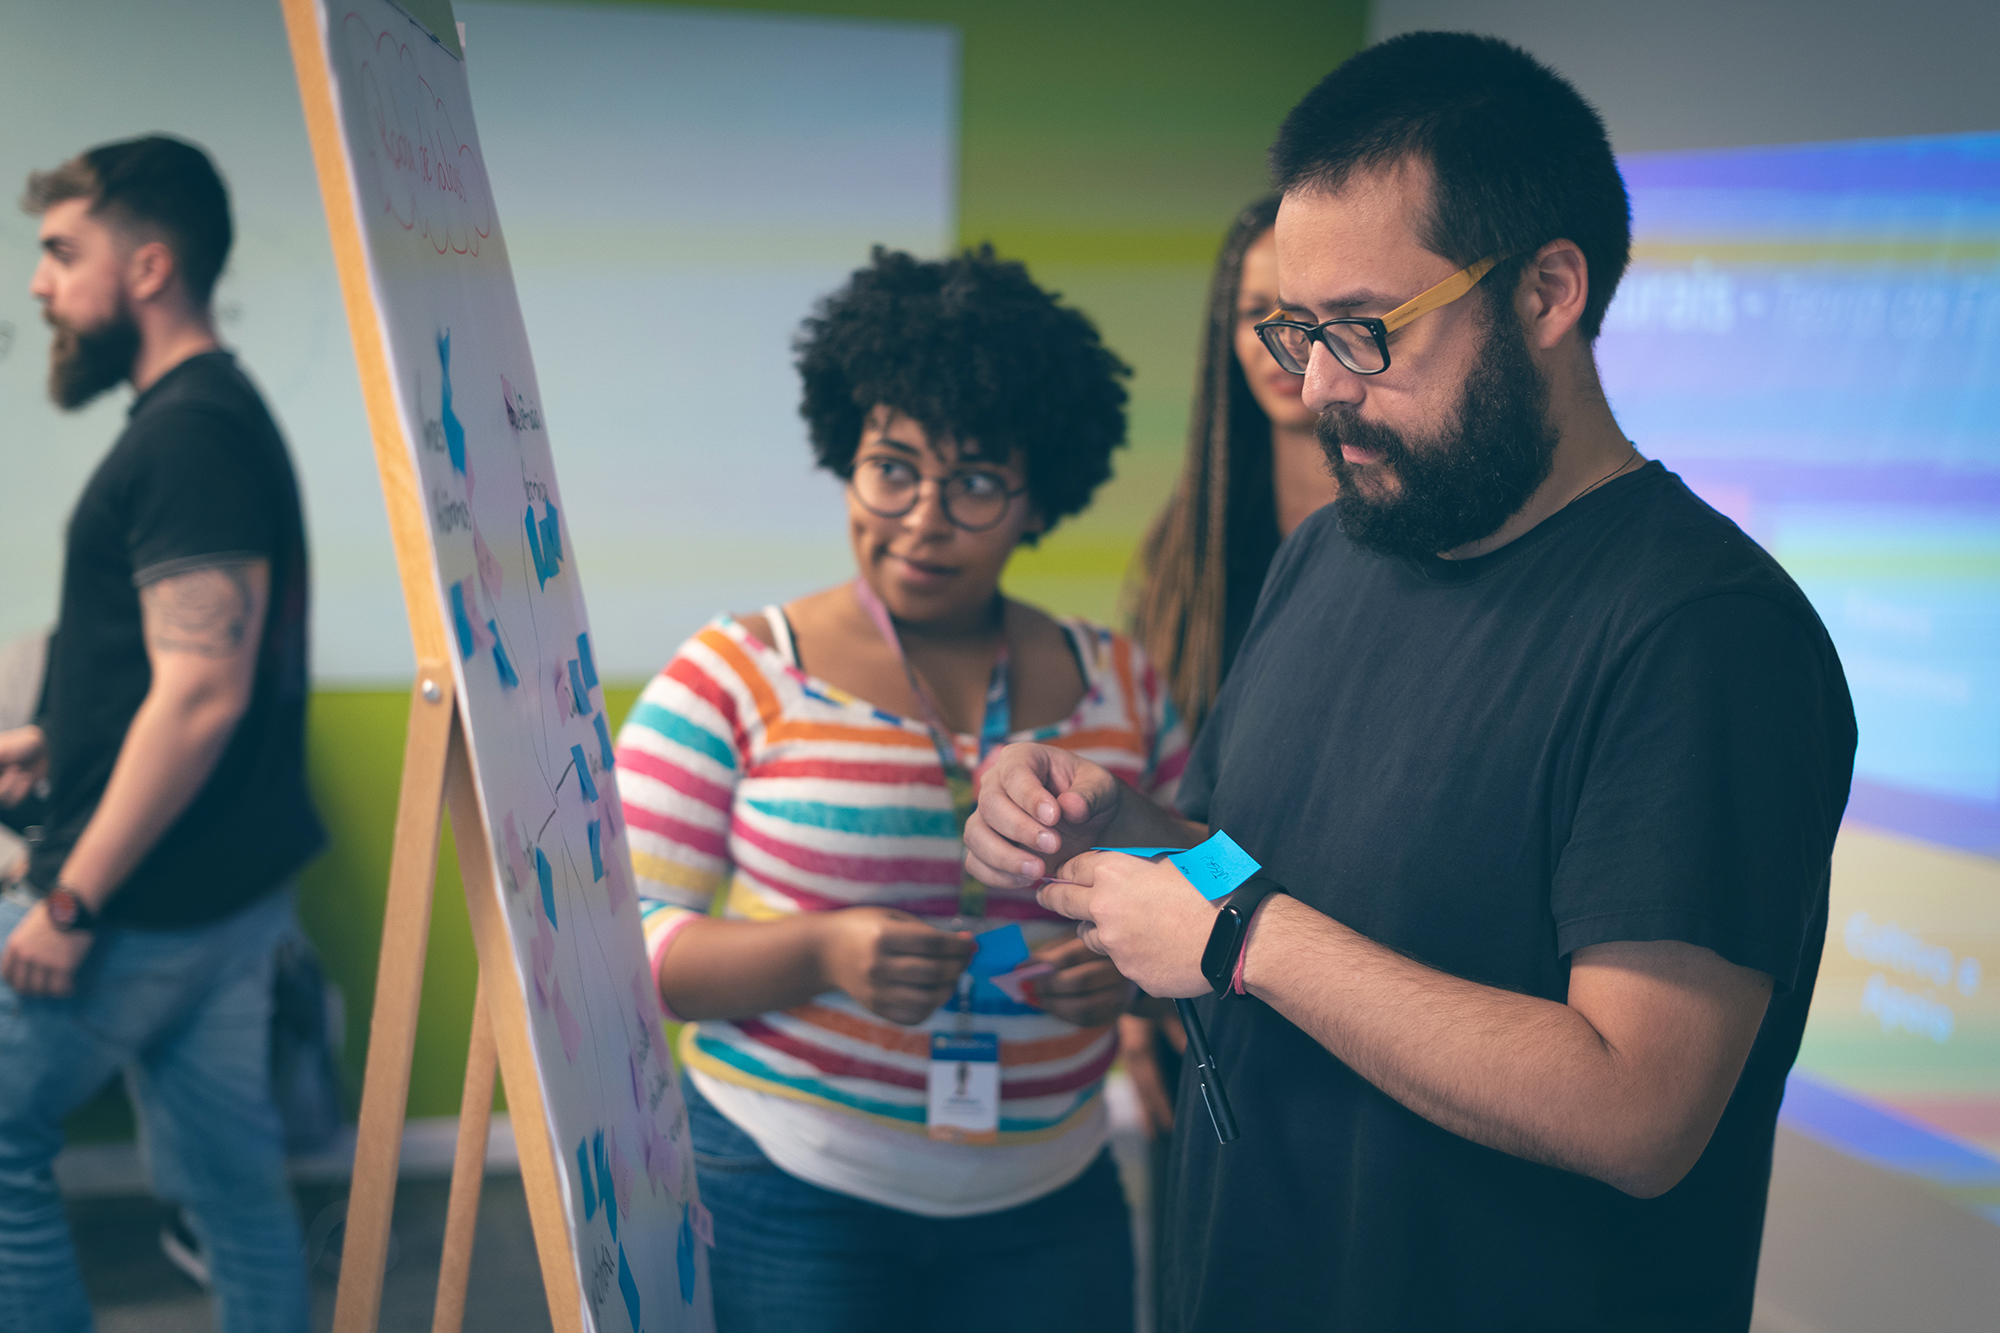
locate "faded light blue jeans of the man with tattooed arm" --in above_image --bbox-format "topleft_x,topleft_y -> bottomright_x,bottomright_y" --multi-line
0,876 -> 308,1333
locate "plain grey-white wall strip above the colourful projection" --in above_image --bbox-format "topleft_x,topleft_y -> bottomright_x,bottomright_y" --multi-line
1368,0 -> 2000,152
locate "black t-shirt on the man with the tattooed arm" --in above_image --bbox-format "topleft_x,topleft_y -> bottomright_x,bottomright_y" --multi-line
28,352 -> 326,929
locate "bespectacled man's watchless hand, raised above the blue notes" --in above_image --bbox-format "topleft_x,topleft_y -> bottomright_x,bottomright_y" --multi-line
966,745 -> 1126,889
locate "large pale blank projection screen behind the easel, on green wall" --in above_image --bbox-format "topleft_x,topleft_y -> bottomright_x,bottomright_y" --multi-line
0,0 -> 958,689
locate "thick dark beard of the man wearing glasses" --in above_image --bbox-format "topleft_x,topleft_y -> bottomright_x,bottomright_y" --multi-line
1318,312 -> 1556,556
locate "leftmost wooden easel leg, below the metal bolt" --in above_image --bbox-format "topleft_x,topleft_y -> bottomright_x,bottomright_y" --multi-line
334,662 -> 456,1333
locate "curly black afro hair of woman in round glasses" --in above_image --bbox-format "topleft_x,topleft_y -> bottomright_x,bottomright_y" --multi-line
792,246 -> 1132,526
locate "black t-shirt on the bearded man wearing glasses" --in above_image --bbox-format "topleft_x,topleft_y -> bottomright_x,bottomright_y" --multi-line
1162,464 -> 1854,1333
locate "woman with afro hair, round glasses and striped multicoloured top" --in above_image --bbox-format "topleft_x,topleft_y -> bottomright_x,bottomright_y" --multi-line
618,248 -> 1186,1333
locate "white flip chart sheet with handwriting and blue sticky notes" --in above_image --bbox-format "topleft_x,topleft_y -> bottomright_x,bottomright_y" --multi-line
322,0 -> 714,1333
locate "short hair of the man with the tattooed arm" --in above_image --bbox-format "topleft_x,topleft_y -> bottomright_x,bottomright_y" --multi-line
20,134 -> 236,306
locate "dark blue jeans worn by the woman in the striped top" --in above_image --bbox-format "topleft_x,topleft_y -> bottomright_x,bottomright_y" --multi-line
680,1079 -> 1132,1333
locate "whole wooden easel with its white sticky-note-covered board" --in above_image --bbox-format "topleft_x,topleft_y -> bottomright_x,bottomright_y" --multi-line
282,0 -> 712,1333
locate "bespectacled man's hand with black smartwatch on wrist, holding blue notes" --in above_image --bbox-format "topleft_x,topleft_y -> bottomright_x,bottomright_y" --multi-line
1032,852 -> 1220,999
